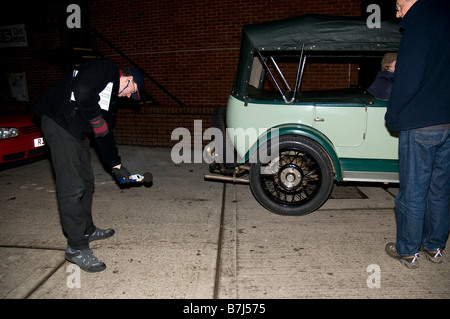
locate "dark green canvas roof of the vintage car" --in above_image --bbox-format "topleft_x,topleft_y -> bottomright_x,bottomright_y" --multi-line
242,14 -> 401,51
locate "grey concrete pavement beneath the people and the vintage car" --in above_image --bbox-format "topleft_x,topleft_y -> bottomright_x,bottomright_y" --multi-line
0,146 -> 450,299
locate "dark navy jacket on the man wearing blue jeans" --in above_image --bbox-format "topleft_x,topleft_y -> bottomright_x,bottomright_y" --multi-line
385,0 -> 450,130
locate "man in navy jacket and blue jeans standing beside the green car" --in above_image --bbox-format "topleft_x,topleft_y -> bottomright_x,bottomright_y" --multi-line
385,0 -> 450,268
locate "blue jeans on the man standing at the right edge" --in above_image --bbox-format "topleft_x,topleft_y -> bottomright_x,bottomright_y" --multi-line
395,129 -> 450,256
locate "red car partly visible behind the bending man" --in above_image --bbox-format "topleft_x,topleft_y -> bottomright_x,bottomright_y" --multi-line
0,105 -> 47,170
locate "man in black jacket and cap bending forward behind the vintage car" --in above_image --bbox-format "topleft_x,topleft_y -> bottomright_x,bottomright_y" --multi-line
34,60 -> 143,272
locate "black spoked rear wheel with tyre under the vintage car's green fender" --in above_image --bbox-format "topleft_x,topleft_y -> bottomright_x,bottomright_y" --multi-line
250,136 -> 334,216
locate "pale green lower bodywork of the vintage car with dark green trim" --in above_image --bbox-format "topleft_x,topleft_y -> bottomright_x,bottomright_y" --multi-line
226,96 -> 398,183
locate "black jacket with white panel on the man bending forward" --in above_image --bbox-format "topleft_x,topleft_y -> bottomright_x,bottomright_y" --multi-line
34,60 -> 121,167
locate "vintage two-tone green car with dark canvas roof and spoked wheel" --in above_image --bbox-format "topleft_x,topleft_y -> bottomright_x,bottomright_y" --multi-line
208,14 -> 401,215
